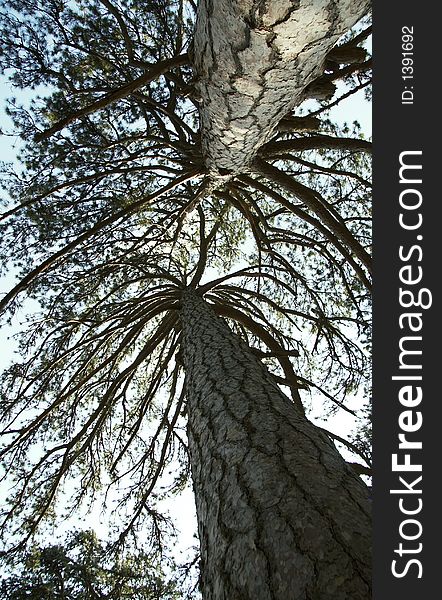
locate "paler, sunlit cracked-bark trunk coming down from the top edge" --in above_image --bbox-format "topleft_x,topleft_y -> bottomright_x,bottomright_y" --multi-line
194,0 -> 370,176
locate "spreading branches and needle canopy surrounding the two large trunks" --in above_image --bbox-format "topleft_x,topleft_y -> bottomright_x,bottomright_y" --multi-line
0,0 -> 371,572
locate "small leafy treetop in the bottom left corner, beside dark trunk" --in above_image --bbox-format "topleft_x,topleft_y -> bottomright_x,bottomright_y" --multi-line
0,531 -> 181,600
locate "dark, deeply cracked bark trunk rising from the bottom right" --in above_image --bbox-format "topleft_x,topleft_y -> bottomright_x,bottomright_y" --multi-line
182,292 -> 371,600
